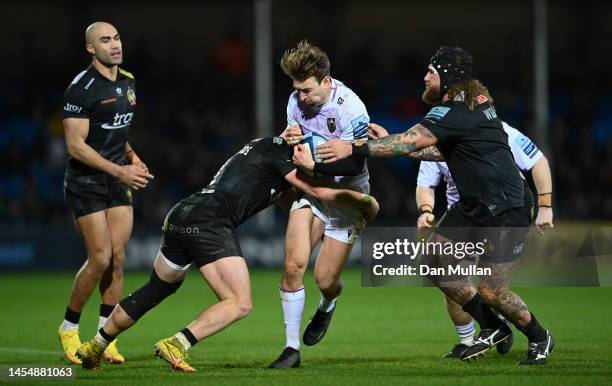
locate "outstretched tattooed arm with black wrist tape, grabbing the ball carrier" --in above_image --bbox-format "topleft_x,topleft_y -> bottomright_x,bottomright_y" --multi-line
316,124 -> 439,162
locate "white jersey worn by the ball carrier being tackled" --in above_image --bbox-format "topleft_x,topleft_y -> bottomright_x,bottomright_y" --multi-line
287,79 -> 370,188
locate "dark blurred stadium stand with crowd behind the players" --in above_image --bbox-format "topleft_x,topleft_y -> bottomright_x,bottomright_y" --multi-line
0,1 -> 612,232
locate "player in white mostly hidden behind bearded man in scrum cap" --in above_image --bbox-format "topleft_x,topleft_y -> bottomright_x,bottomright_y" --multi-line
368,122 -> 554,359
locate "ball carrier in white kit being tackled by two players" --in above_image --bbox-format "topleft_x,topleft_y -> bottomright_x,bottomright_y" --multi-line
270,41 -> 370,368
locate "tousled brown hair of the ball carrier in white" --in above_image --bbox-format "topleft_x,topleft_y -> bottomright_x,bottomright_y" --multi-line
280,40 -> 331,83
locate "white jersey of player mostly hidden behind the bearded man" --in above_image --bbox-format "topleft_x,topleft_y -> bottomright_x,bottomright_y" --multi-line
417,121 -> 543,206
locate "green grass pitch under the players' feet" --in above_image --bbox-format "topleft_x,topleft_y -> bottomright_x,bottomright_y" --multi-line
0,270 -> 612,385
